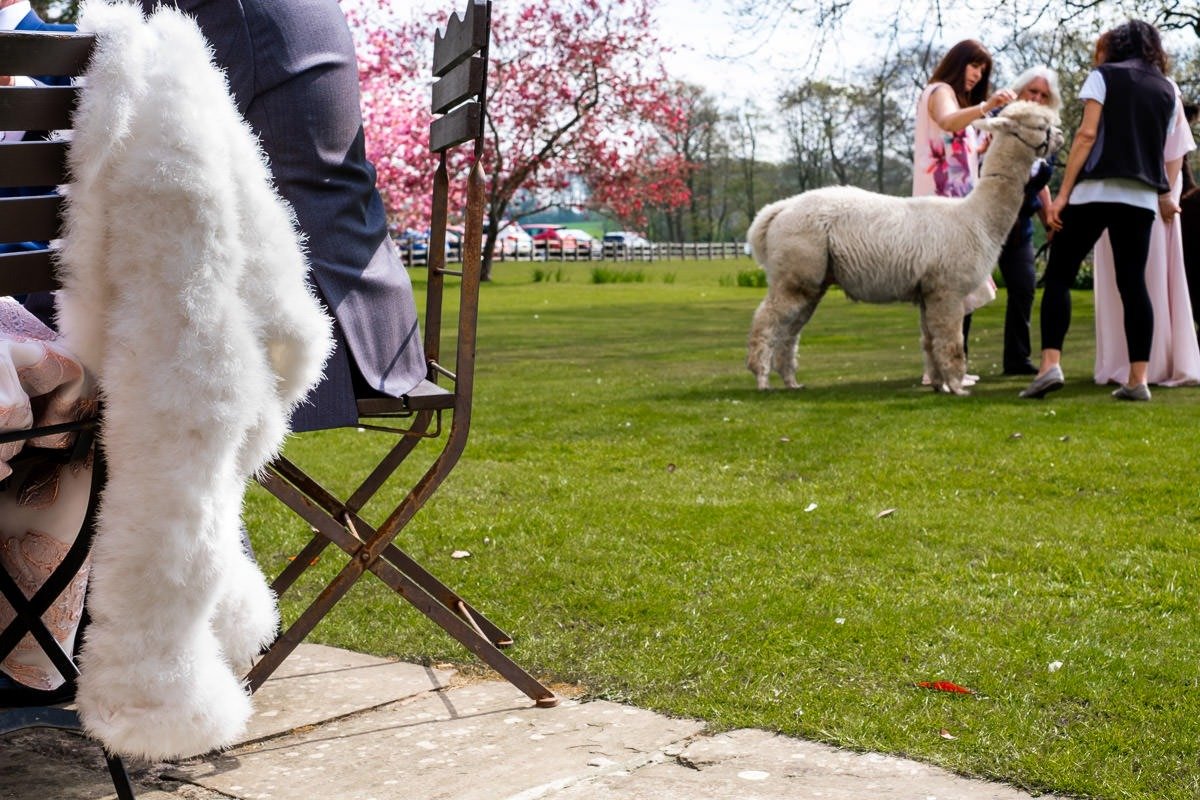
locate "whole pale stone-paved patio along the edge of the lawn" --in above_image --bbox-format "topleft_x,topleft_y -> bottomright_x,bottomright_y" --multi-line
0,644 -> 1070,800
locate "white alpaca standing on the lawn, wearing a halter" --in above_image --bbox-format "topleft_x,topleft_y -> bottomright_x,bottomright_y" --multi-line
746,102 -> 1062,395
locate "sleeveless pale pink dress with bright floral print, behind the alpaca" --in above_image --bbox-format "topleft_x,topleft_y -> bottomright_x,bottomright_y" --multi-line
912,83 -> 996,313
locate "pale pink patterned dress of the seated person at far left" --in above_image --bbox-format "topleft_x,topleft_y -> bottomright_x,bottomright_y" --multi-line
0,297 -> 95,690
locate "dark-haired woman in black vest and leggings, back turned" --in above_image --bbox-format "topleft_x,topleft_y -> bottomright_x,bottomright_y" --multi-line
1021,19 -> 1178,401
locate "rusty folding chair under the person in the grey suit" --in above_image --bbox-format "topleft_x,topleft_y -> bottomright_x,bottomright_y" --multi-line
247,0 -> 558,706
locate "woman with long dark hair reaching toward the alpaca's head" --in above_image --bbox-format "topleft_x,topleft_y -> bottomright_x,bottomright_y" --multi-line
912,38 -> 1016,386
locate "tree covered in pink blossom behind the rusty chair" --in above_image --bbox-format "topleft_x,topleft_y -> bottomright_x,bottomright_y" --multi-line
349,0 -> 691,278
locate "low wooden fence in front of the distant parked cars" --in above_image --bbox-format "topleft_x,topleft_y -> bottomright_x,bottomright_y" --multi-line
397,241 -> 749,265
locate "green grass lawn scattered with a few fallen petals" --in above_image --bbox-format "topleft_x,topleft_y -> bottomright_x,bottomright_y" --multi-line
243,259 -> 1200,800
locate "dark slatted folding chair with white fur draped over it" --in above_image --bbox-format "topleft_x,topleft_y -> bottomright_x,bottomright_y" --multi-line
0,26 -> 133,800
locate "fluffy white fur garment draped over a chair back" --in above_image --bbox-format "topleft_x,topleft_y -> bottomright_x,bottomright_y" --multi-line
58,2 -> 331,759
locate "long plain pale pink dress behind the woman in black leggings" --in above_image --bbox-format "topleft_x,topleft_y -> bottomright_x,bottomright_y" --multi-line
1093,89 -> 1200,386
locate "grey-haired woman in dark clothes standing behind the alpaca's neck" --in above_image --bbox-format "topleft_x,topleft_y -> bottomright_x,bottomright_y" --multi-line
1000,65 -> 1062,375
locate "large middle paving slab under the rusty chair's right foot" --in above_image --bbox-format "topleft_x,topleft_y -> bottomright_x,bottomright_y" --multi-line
174,681 -> 703,800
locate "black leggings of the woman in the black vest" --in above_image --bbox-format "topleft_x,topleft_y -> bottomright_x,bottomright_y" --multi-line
1042,203 -> 1154,361
